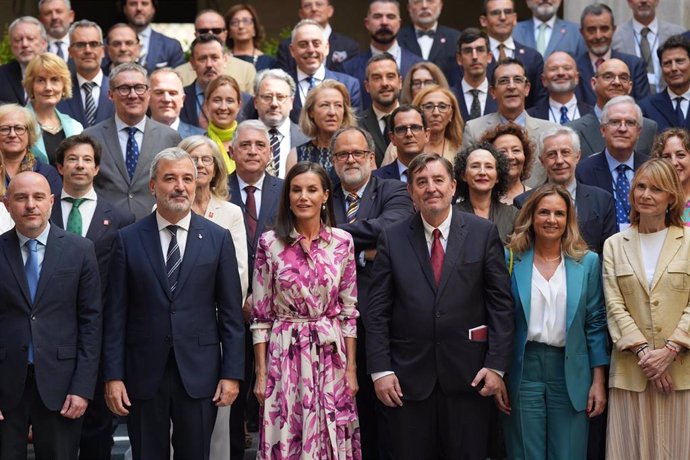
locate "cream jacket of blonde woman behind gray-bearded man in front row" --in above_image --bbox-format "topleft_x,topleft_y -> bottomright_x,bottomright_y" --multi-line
204,195 -> 249,302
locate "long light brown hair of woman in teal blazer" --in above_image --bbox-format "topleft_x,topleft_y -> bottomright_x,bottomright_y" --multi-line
508,184 -> 587,261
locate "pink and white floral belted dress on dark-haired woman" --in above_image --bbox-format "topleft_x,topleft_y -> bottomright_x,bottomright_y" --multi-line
251,226 -> 362,460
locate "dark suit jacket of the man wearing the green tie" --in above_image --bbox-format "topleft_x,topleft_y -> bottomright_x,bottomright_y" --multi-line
50,195 -> 134,295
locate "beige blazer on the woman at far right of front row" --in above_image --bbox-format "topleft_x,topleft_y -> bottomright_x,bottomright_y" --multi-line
603,227 -> 690,391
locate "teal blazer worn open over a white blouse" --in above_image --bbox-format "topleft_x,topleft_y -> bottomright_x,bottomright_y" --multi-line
505,249 -> 609,411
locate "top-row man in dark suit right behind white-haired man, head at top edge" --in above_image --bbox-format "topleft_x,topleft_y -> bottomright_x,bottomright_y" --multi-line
276,0 -> 359,75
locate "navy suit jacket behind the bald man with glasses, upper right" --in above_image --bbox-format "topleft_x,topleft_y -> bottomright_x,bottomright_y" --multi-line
575,50 -> 649,106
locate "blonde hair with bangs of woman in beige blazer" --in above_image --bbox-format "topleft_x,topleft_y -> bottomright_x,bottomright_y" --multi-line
628,158 -> 685,227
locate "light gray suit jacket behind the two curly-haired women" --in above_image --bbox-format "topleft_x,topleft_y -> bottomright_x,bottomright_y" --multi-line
462,113 -> 557,188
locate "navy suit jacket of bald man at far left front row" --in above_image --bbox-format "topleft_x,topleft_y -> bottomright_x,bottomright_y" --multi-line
0,225 -> 103,412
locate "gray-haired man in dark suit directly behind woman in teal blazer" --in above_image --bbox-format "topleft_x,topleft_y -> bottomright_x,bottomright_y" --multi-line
513,126 -> 616,255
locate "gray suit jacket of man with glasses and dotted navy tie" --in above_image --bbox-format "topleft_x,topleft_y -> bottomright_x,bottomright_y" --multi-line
84,117 -> 182,220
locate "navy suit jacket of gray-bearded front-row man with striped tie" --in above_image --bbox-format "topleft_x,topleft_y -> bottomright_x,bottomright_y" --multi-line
103,213 -> 244,399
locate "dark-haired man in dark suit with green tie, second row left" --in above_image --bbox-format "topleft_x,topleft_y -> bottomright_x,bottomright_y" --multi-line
50,134 -> 134,460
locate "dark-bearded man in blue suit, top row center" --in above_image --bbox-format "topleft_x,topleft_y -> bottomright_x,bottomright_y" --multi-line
342,0 -> 422,109
